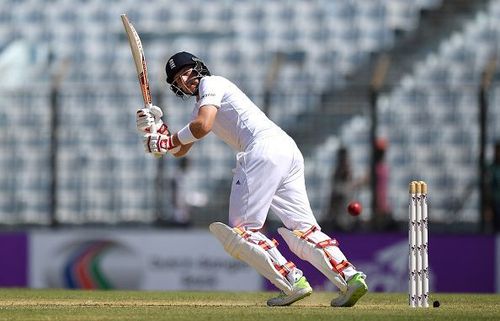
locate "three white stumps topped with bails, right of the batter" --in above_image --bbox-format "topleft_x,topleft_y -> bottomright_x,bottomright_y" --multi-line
408,181 -> 429,308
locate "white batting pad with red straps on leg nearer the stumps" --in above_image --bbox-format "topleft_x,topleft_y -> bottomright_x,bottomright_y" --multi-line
278,227 -> 347,292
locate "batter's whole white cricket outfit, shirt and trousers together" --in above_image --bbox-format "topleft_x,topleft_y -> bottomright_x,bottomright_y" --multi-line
193,76 -> 319,230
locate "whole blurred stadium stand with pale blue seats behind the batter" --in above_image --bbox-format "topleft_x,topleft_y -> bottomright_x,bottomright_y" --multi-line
0,0 -> 500,291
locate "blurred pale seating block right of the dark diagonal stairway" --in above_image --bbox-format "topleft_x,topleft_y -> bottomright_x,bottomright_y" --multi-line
311,1 -> 500,222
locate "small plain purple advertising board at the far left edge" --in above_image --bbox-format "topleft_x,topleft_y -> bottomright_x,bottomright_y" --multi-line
0,232 -> 28,287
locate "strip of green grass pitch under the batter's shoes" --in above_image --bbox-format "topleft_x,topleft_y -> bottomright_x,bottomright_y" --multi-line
0,289 -> 500,321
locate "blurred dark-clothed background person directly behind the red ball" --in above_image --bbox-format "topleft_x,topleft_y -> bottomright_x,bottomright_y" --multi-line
325,146 -> 358,231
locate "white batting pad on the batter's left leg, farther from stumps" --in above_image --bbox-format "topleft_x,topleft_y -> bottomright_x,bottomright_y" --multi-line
209,222 -> 292,295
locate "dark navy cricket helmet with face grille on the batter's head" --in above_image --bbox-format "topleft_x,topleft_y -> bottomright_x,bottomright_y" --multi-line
165,51 -> 210,97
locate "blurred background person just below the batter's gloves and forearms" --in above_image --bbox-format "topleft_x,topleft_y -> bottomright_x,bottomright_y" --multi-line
171,157 -> 191,227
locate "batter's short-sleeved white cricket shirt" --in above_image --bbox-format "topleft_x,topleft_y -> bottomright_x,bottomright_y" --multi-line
193,76 -> 285,152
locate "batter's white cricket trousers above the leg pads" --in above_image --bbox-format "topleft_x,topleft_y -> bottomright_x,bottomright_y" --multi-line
229,134 -> 318,230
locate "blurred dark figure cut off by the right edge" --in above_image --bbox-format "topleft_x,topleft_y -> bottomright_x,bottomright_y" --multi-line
486,140 -> 500,232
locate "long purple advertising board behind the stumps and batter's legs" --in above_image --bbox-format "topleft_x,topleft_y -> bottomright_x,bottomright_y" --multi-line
266,233 -> 496,293
